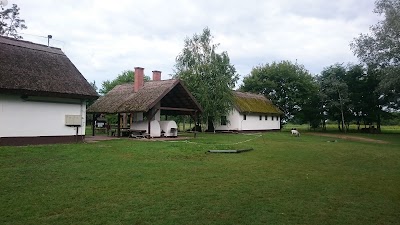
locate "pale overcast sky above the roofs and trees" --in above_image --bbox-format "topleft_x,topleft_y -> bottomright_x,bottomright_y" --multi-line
8,0 -> 378,87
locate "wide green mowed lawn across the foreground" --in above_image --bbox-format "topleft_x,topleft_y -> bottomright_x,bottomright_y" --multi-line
0,132 -> 400,225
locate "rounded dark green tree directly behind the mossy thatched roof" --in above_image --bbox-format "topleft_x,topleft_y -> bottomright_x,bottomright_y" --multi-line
240,61 -> 317,121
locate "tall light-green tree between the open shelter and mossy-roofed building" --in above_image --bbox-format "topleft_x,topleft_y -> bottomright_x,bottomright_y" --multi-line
174,28 -> 239,131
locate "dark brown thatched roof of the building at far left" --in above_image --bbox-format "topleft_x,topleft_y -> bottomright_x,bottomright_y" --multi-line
0,37 -> 98,99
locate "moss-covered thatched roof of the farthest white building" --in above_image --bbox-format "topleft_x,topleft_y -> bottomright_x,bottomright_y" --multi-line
233,91 -> 282,114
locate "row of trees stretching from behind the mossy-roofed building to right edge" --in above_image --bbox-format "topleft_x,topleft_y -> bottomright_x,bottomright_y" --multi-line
241,0 -> 400,132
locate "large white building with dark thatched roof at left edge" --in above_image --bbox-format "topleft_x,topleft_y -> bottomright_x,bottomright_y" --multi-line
0,37 -> 97,145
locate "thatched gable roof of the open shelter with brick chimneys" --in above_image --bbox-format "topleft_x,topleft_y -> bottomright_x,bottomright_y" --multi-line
87,80 -> 202,113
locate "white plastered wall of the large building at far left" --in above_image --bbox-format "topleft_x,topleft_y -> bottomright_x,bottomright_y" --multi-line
0,94 -> 86,137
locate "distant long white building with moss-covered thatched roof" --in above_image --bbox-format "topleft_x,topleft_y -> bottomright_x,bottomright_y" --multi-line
215,91 -> 282,131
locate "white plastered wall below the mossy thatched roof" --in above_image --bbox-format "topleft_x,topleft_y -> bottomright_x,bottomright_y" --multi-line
215,109 -> 280,131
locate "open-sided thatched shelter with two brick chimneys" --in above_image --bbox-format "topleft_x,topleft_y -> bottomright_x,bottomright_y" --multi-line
87,67 -> 202,137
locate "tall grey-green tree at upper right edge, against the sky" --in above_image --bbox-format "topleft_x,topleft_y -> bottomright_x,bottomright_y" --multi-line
350,0 -> 400,109
